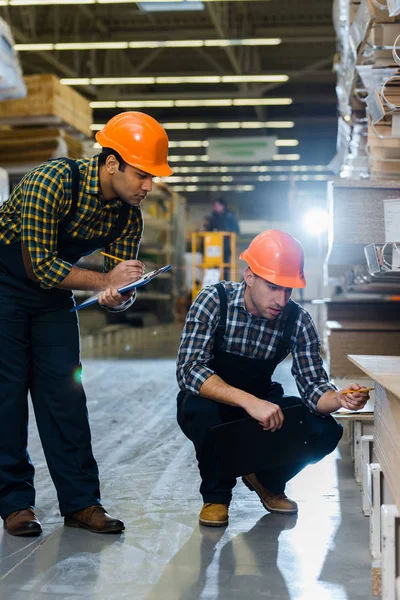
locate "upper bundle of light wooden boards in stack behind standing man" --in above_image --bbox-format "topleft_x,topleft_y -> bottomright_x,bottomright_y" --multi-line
0,75 -> 93,137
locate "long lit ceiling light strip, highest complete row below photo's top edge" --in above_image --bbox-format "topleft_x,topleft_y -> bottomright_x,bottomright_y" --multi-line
15,38 -> 282,52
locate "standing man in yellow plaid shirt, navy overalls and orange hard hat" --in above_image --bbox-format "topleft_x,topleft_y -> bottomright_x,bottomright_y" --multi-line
0,112 -> 172,535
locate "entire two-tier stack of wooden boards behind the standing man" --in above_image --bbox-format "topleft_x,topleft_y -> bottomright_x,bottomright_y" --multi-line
0,75 -> 92,172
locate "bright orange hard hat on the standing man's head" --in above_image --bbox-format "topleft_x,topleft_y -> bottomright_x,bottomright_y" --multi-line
96,111 -> 172,177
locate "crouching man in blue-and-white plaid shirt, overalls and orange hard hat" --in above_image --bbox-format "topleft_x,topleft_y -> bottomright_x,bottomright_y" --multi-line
177,230 -> 369,527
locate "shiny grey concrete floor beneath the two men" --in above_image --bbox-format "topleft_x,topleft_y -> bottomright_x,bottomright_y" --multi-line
0,360 -> 372,600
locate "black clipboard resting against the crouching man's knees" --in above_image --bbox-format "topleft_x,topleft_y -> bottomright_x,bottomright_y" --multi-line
210,404 -> 312,478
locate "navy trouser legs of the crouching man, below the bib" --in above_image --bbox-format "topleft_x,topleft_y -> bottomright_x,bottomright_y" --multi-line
178,392 -> 343,504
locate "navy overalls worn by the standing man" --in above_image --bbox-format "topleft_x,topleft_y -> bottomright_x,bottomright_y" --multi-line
0,159 -> 129,518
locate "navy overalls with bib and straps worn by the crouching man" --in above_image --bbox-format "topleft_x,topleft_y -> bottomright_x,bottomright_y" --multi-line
178,284 -> 343,504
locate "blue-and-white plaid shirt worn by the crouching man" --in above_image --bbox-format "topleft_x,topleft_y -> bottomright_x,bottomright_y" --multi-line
177,281 -> 336,413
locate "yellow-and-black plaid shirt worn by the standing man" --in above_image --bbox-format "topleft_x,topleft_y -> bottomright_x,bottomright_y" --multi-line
0,156 -> 143,289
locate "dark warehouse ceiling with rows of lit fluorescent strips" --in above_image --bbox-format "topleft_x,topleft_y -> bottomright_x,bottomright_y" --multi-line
0,0 -> 337,206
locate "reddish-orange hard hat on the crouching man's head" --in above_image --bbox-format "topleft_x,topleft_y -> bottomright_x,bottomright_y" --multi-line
240,229 -> 306,288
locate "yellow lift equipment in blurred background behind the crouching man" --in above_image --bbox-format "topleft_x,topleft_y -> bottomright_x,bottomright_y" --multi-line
192,231 -> 236,301
